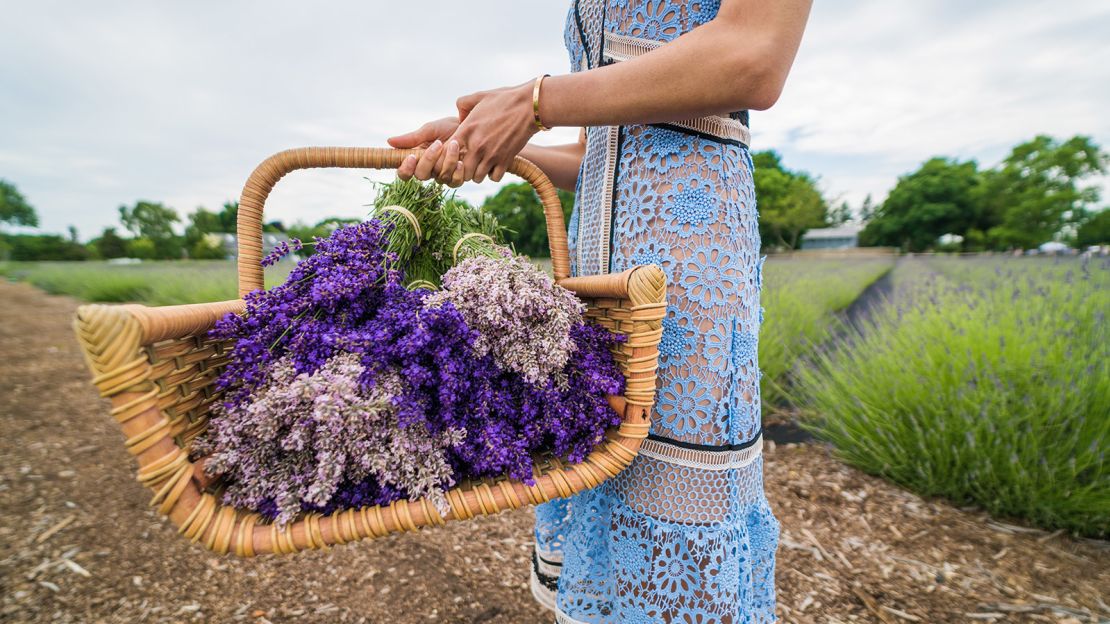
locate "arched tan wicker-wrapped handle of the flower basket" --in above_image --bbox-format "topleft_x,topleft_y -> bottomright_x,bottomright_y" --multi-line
229,148 -> 571,296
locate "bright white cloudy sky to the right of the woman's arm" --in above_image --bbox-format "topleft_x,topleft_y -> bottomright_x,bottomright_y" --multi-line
753,0 -> 1110,202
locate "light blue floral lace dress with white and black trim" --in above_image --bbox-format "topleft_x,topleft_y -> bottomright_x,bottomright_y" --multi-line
532,0 -> 779,624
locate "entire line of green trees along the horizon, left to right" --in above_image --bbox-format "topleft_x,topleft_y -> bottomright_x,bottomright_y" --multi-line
0,135 -> 1110,260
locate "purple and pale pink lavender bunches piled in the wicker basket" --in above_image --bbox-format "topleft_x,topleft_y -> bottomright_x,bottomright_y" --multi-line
193,182 -> 624,524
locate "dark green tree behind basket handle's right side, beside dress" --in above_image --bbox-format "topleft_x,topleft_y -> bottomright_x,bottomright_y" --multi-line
482,182 -> 574,258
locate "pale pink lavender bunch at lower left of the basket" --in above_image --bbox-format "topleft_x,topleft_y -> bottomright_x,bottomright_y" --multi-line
194,353 -> 465,524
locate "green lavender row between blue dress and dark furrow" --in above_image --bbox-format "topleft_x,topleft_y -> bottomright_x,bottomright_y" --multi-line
759,256 -> 894,407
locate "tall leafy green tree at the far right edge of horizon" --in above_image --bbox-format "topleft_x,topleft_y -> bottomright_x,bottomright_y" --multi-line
977,135 -> 1107,249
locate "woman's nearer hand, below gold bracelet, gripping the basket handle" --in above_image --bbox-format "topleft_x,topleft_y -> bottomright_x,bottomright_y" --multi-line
448,81 -> 538,182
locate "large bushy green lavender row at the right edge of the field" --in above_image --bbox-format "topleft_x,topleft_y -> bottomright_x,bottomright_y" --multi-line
797,258 -> 1110,537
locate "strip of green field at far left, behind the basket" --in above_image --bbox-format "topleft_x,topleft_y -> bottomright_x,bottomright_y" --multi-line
0,260 -> 292,305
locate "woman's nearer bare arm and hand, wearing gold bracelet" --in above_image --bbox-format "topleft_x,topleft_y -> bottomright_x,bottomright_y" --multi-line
446,0 -> 811,182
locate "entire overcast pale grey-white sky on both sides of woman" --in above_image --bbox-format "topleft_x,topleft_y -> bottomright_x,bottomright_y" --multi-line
0,0 -> 1110,238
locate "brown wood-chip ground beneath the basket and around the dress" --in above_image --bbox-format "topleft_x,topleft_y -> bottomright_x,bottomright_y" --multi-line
0,283 -> 1110,624
